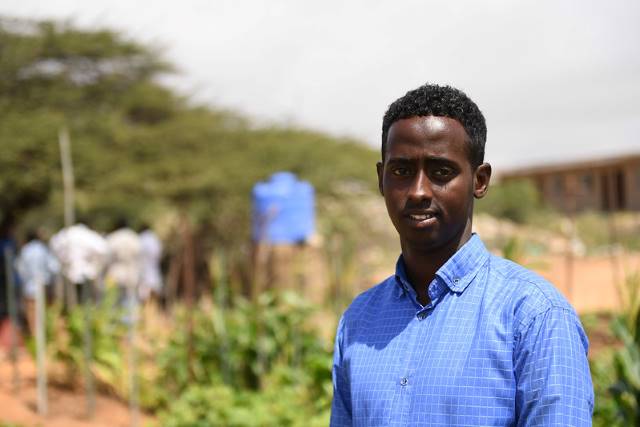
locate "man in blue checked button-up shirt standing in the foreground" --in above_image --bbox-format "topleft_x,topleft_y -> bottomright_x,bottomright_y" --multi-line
331,85 -> 593,427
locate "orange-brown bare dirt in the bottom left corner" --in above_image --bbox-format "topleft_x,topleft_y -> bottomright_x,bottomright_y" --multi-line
0,351 -> 153,427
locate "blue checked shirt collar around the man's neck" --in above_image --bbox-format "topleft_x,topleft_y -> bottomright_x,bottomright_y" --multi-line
396,233 -> 489,296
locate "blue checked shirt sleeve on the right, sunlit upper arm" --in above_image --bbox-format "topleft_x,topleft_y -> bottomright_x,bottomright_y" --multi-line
514,307 -> 593,426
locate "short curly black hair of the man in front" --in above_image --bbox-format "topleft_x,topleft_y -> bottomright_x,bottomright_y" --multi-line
382,83 -> 487,168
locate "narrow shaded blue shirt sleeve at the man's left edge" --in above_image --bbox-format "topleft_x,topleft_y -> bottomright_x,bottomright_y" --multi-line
330,317 -> 352,427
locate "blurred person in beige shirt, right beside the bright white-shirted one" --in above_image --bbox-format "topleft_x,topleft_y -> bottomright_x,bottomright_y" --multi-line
107,218 -> 141,308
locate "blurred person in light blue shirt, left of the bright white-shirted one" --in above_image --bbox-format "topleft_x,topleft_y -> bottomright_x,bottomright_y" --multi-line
16,230 -> 60,333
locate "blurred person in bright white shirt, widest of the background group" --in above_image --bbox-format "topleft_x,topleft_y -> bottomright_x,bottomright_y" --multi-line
49,223 -> 109,301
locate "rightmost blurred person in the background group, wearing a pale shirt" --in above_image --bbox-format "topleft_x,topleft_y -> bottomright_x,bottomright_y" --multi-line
138,224 -> 162,301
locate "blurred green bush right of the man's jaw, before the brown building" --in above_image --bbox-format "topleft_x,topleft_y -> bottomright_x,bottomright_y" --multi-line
475,180 -> 548,224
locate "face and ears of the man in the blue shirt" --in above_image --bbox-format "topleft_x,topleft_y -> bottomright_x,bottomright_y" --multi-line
378,116 -> 491,252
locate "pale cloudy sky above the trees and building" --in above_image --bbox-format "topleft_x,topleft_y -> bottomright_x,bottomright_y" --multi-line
0,0 -> 640,171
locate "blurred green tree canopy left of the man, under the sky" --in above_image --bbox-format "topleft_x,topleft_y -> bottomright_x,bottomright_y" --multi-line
0,18 -> 377,246
